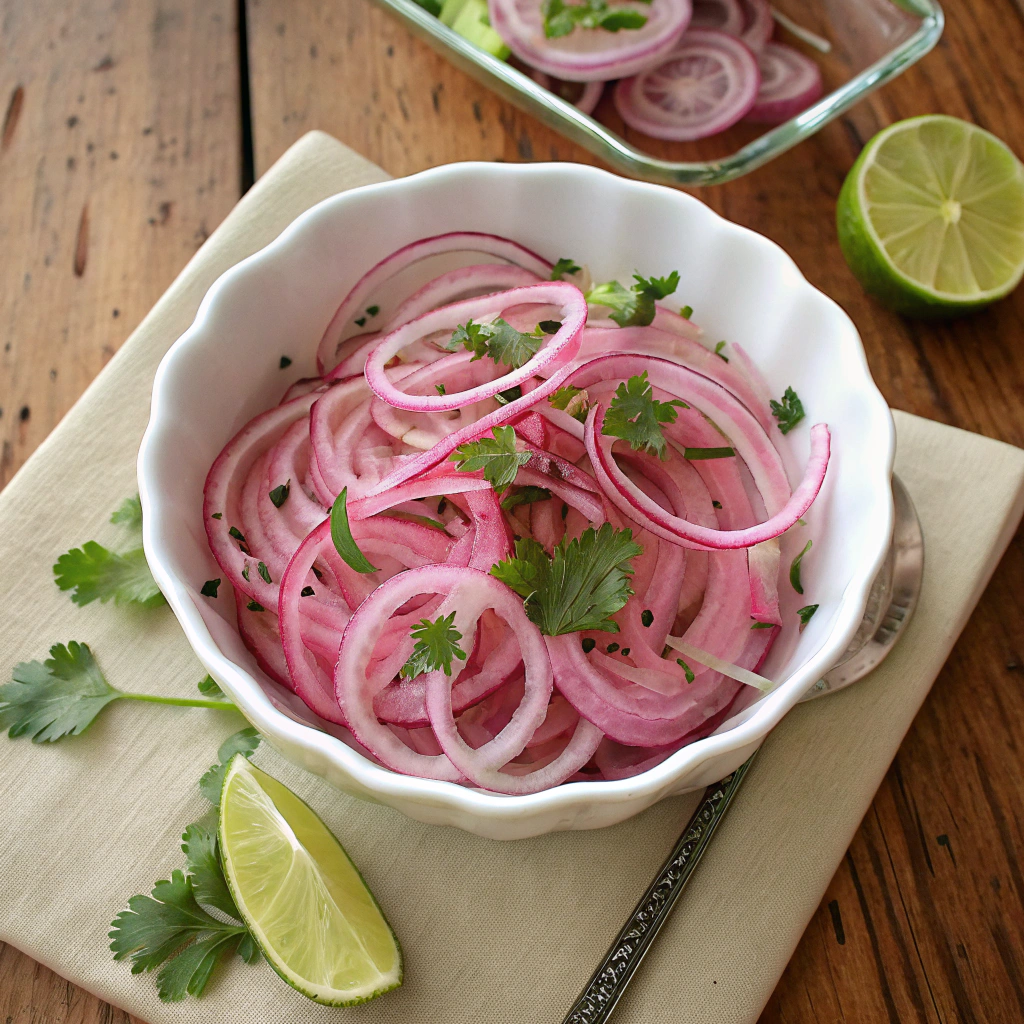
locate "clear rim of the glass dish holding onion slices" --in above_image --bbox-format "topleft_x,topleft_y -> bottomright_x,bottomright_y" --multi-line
377,0 -> 945,185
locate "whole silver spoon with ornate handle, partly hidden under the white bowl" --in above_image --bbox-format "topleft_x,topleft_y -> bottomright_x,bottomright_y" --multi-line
562,476 -> 925,1024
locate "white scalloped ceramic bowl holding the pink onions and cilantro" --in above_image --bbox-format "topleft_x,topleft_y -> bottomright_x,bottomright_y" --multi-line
138,164 -> 895,839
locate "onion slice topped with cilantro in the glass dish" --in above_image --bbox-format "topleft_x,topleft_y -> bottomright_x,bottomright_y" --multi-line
487,0 -> 691,82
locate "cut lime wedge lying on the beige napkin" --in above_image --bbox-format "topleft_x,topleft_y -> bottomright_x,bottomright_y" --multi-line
220,754 -> 402,1007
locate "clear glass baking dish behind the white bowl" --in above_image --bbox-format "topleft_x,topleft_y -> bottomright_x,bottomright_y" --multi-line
368,0 -> 943,185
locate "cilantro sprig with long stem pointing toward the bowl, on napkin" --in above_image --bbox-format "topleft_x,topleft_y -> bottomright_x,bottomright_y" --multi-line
0,640 -> 234,743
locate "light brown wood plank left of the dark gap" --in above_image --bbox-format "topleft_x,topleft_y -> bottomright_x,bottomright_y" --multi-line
0,0 -> 242,1024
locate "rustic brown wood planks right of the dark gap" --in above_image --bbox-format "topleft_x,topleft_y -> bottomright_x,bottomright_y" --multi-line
248,0 -> 1024,1024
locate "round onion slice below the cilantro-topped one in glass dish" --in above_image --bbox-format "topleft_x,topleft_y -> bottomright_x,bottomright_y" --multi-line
614,29 -> 761,142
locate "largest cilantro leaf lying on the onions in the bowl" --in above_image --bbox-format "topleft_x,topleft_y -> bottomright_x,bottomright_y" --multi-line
490,522 -> 643,636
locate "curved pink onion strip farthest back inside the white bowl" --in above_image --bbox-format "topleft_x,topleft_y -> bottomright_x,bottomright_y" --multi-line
316,231 -> 551,373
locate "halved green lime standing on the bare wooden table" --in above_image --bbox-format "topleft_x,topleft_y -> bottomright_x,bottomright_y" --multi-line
836,114 -> 1024,316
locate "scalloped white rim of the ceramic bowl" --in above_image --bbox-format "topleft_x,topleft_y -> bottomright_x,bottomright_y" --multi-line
138,162 -> 895,827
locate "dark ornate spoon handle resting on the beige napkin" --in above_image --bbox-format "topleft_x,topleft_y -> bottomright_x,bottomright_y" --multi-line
562,752 -> 756,1024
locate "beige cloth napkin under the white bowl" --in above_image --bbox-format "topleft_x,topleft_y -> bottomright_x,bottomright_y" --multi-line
0,134 -> 1024,1024
